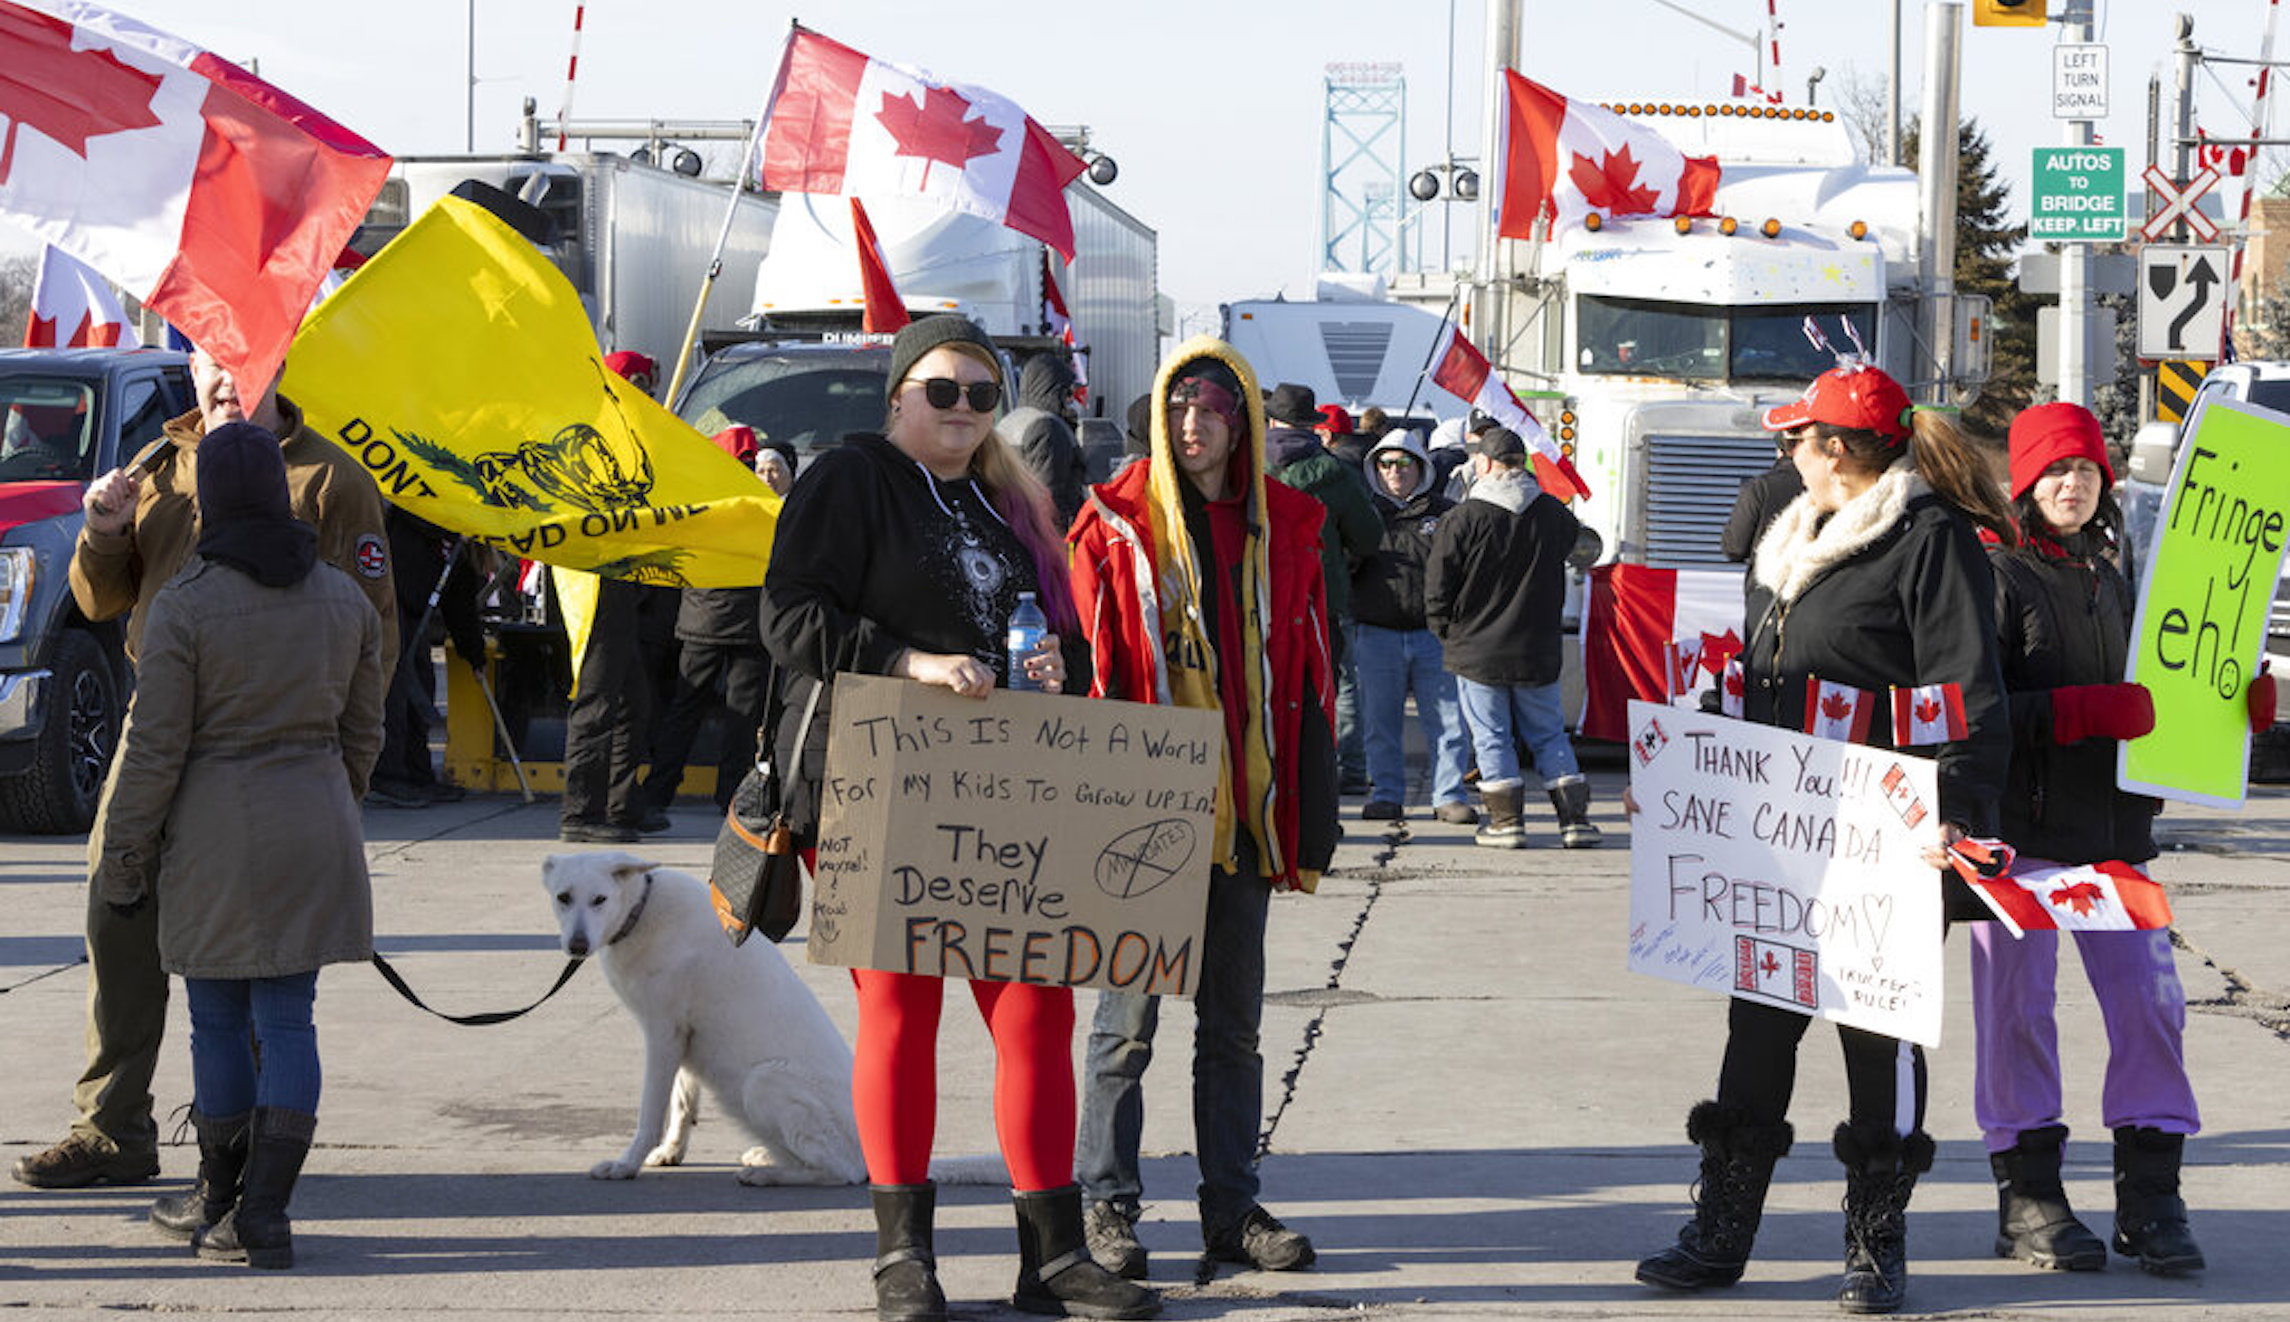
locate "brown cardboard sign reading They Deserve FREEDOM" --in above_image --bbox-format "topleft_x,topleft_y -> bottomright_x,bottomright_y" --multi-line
808,674 -> 1225,997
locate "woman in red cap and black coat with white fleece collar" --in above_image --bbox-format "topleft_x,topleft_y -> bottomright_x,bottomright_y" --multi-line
1637,367 -> 2015,1313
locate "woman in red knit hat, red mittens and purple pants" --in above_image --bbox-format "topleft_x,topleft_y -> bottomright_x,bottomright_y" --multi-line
1972,403 -> 2203,1276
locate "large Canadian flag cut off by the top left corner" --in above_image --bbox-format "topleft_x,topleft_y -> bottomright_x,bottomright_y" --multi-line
0,0 -> 389,396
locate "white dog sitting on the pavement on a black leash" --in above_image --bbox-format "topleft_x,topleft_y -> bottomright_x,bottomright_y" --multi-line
540,850 -> 1010,1185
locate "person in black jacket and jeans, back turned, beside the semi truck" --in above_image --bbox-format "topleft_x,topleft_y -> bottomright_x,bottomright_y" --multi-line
1424,426 -> 1598,850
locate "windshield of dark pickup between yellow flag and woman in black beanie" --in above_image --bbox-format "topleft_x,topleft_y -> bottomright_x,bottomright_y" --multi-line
678,344 -> 891,456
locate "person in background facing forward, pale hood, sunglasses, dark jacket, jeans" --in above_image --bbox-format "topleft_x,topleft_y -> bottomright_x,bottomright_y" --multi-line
1351,426 -> 1479,825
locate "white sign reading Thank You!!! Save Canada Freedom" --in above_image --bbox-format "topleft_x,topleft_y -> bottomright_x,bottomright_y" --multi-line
1630,701 -> 1942,1047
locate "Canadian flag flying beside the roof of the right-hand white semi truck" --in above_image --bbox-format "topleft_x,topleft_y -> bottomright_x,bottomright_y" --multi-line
1495,69 -> 1718,238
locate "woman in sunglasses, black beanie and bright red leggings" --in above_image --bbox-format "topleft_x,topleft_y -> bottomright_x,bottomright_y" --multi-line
763,316 -> 1161,1322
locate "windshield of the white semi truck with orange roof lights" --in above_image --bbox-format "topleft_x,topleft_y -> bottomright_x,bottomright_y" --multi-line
1578,293 -> 1876,380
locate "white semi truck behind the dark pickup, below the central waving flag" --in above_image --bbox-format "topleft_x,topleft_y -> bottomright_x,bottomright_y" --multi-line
749,181 -> 1166,419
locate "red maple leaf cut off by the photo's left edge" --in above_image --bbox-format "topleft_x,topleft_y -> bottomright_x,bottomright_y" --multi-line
0,5 -> 160,183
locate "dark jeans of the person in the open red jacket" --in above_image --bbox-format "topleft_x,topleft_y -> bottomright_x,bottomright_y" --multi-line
1074,841 -> 1273,1235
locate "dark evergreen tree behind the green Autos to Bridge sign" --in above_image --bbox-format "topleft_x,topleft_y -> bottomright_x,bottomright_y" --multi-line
1901,119 -> 2036,438
